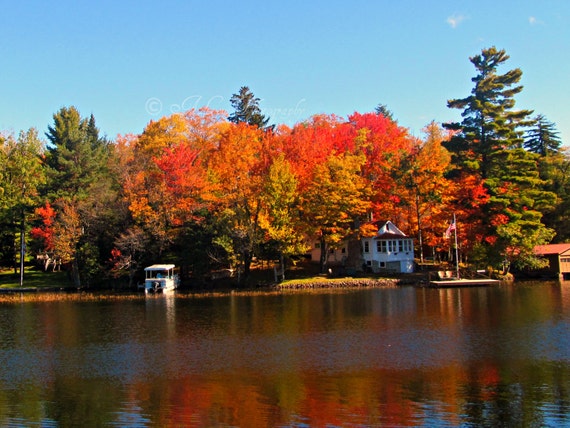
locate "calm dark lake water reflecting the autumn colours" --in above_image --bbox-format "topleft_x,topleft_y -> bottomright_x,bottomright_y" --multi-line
0,282 -> 570,427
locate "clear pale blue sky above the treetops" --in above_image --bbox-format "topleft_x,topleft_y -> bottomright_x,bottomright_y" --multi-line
0,0 -> 570,145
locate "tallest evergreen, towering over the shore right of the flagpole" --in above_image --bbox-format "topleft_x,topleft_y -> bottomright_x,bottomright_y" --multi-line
446,47 -> 555,268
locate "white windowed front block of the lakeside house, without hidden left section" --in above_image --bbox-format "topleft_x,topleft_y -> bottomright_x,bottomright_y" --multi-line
361,221 -> 414,273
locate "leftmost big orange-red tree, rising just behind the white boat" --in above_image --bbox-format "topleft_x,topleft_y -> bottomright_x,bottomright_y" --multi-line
118,108 -> 224,255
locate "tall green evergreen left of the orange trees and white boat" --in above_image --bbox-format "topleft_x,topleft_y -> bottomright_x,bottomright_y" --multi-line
45,107 -> 117,287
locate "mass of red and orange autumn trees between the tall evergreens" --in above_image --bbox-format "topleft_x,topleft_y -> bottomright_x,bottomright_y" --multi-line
112,105 -> 470,280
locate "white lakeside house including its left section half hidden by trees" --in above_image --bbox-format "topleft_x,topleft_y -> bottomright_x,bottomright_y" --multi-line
311,221 -> 414,273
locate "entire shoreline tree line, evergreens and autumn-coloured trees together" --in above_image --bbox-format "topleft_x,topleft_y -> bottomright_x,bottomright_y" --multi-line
0,47 -> 570,286
